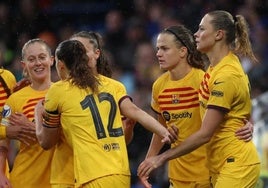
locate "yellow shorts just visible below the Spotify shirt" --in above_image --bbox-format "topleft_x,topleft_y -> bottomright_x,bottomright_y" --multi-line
169,179 -> 211,188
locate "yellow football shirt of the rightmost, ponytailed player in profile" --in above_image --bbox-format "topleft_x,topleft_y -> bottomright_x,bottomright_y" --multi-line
199,53 -> 260,173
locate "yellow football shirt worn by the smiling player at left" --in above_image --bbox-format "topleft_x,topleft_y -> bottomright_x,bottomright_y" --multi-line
6,86 -> 54,188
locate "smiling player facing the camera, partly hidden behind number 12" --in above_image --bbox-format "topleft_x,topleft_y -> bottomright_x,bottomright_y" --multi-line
0,39 -> 54,188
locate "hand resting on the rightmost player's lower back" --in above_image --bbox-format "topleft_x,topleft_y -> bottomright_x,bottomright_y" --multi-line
235,120 -> 254,142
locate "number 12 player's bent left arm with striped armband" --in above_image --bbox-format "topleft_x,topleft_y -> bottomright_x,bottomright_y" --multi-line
35,101 -> 61,150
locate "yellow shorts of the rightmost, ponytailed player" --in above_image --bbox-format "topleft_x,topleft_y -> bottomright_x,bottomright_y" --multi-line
211,163 -> 260,188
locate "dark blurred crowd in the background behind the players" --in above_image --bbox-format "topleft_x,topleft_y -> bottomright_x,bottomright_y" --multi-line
0,0 -> 268,188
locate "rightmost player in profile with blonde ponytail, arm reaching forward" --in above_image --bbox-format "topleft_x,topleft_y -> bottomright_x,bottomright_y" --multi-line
138,11 -> 260,188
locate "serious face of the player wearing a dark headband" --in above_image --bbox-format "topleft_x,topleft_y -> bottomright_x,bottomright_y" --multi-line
156,33 -> 181,70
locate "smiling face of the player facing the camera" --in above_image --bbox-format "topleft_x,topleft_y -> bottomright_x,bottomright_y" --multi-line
22,42 -> 54,82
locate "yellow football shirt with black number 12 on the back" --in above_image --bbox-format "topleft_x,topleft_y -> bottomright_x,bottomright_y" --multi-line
45,75 -> 130,185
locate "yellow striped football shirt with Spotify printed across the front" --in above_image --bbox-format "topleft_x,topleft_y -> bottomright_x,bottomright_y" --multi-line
151,68 -> 209,181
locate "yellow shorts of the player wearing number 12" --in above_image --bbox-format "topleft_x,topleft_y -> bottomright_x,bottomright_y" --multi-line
79,175 -> 130,188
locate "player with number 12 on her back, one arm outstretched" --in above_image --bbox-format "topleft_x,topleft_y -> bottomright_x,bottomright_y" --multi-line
35,40 -> 176,187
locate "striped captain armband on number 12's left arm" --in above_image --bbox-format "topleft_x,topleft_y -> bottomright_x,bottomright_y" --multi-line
42,111 -> 60,128
